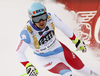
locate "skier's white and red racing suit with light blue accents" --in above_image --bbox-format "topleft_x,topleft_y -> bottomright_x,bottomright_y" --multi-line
16,13 -> 95,76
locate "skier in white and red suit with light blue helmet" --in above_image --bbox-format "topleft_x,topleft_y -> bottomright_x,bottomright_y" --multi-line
16,2 -> 99,76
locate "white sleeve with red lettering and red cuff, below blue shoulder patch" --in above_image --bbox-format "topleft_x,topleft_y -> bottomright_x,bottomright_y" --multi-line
16,38 -> 29,66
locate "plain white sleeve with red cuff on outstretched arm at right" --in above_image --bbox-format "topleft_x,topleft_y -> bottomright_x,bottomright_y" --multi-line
51,14 -> 76,40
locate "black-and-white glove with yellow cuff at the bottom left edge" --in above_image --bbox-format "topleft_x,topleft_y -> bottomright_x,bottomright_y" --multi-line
26,63 -> 38,76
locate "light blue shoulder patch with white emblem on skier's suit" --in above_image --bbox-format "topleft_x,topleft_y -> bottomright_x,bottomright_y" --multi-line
20,29 -> 31,44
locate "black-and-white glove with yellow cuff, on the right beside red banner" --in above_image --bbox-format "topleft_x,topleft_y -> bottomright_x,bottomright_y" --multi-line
72,38 -> 87,52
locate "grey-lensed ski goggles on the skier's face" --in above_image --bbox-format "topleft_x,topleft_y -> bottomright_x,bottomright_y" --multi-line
32,12 -> 47,23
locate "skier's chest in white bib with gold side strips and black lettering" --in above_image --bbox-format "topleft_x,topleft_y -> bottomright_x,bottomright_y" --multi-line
27,22 -> 55,49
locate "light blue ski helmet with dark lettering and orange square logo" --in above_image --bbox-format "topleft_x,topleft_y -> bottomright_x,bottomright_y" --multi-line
28,2 -> 47,18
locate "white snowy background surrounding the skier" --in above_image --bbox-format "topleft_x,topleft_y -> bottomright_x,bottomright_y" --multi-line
0,0 -> 100,76
